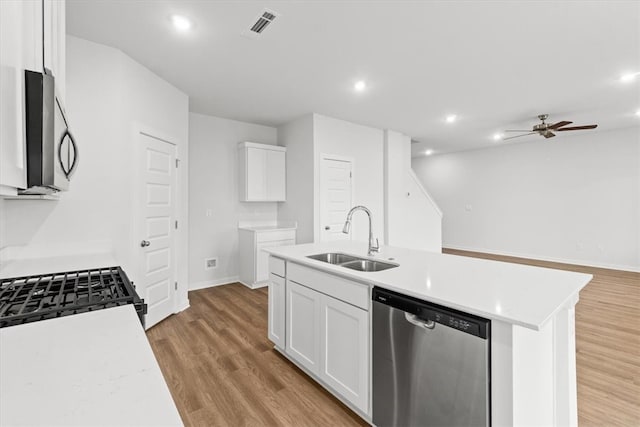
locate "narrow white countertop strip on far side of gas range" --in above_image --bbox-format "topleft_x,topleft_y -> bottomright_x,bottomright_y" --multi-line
0,253 -> 119,279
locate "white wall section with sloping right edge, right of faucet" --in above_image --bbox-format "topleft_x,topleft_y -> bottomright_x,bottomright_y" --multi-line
384,130 -> 442,252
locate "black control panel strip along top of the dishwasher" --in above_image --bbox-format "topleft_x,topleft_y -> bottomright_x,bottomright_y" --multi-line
372,287 -> 491,338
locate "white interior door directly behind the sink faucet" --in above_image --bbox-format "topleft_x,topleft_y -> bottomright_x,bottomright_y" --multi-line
320,157 -> 353,242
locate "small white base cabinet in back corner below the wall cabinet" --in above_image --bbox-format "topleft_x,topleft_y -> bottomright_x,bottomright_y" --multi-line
239,227 -> 296,288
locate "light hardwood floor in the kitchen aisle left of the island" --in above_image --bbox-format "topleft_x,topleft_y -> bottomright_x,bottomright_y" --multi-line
147,283 -> 367,426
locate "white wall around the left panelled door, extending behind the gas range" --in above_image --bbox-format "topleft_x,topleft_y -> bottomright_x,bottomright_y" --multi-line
0,36 -> 188,307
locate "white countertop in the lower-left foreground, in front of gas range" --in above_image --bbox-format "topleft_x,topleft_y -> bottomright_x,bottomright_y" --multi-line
0,305 -> 182,426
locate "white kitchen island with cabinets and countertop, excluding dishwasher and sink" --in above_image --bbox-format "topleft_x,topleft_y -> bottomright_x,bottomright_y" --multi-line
265,242 -> 591,426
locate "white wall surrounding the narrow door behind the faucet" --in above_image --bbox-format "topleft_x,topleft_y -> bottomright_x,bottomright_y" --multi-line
313,114 -> 384,242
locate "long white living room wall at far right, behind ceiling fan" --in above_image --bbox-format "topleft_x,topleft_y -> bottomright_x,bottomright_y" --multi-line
413,127 -> 640,271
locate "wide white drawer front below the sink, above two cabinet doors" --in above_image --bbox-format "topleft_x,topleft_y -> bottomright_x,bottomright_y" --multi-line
287,262 -> 369,311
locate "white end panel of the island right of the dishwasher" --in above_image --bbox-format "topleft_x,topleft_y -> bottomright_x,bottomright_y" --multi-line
491,308 -> 578,427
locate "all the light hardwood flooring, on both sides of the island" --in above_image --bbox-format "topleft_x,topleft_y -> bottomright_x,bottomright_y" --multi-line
147,250 -> 640,427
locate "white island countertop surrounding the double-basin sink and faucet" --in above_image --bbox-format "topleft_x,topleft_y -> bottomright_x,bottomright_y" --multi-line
264,241 -> 592,330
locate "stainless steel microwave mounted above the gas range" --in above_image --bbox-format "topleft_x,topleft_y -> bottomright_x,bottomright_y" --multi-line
19,70 -> 78,194
